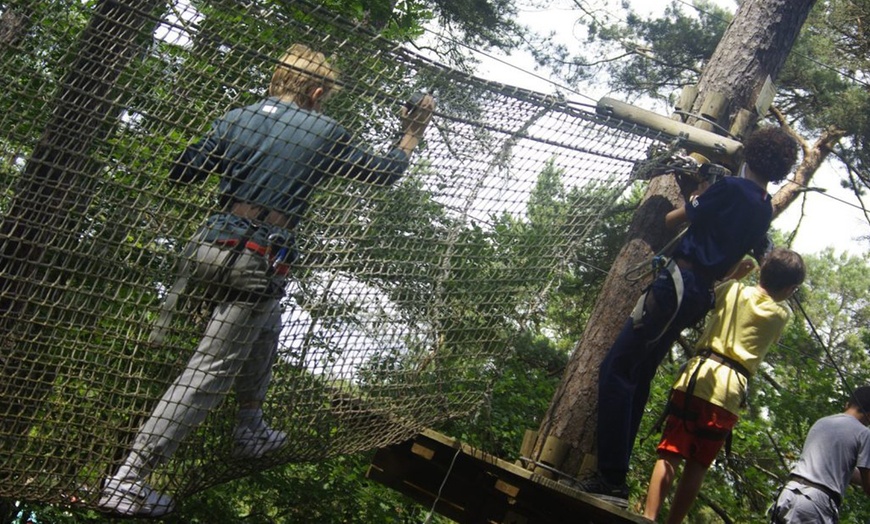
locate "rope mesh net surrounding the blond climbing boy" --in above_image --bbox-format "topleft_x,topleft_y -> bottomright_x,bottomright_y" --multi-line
0,0 -> 657,505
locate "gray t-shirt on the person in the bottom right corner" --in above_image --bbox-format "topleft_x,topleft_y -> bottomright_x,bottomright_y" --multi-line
792,413 -> 870,497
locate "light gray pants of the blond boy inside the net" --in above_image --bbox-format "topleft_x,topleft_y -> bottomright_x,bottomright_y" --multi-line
114,239 -> 284,481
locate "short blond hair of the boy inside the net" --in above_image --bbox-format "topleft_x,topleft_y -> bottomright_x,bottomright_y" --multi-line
269,44 -> 338,106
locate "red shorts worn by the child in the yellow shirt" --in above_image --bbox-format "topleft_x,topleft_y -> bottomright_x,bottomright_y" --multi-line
656,390 -> 738,467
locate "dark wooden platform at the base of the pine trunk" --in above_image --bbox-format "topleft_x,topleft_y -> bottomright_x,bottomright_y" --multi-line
367,430 -> 650,524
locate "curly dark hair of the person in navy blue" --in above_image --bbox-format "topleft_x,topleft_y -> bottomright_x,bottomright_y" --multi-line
743,126 -> 798,182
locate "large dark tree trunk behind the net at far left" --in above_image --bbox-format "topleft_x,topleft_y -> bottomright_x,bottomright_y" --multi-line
0,0 -> 161,438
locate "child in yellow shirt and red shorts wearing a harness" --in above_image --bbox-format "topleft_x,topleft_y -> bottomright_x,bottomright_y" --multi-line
644,248 -> 806,523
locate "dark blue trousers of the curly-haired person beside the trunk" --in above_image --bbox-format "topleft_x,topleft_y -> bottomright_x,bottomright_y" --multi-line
598,269 -> 713,484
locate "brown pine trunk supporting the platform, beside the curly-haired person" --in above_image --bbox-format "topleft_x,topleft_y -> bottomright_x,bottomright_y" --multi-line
532,0 -> 814,475
